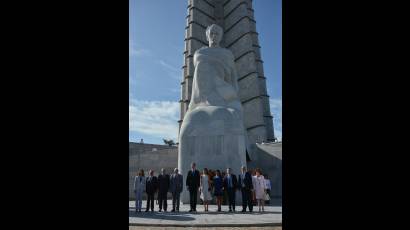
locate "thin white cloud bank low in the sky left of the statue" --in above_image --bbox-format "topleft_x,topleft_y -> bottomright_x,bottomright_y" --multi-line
129,100 -> 179,140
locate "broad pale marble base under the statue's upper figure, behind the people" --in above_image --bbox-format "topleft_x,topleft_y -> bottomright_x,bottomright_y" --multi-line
178,106 -> 246,204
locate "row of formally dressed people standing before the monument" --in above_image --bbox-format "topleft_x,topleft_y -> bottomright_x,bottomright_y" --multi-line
134,163 -> 271,212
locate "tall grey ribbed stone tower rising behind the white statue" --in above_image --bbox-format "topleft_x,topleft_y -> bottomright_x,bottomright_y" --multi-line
178,0 -> 274,153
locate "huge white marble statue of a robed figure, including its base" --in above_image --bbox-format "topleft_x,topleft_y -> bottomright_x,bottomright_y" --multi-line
178,24 -> 246,203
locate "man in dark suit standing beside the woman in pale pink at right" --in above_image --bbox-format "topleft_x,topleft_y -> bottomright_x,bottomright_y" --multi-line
238,166 -> 253,212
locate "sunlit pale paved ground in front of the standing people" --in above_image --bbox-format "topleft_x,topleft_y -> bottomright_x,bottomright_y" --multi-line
129,200 -> 282,226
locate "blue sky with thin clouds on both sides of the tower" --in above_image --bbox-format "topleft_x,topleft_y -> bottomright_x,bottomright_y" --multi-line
129,0 -> 282,144
